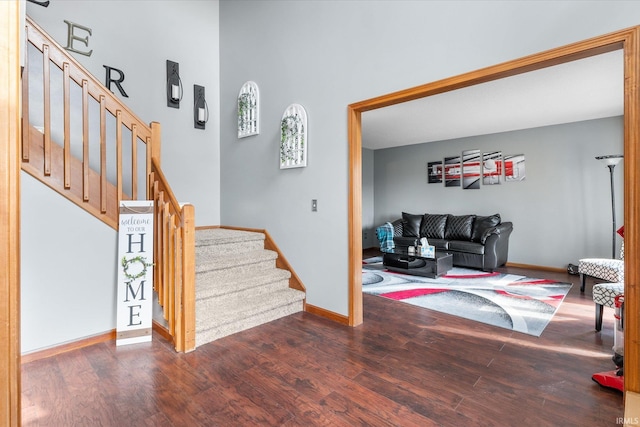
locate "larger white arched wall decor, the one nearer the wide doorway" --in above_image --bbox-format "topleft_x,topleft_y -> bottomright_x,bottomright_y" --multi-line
280,104 -> 308,169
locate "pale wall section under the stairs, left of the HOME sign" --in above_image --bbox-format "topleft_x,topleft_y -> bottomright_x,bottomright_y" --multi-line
20,173 -> 118,353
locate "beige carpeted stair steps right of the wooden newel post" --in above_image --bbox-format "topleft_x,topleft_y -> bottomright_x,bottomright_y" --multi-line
196,228 -> 305,346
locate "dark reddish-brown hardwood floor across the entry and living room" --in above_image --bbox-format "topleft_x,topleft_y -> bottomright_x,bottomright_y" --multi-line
22,254 -> 623,427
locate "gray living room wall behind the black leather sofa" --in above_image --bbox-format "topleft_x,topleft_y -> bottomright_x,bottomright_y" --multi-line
370,117 -> 624,267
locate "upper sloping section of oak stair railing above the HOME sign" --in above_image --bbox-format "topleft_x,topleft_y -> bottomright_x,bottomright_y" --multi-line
22,18 -> 155,229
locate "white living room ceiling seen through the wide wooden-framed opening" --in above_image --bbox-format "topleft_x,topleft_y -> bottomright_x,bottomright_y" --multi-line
362,50 -> 624,150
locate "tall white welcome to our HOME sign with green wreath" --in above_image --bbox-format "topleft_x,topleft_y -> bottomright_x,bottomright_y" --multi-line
116,200 -> 153,345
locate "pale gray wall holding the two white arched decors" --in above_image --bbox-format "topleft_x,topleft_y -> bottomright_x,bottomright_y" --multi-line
220,0 -> 640,314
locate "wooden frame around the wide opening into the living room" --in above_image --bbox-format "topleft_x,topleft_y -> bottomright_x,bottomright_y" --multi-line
347,26 -> 640,402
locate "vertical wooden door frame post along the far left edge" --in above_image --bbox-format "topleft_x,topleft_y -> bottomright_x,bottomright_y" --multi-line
0,0 -> 21,426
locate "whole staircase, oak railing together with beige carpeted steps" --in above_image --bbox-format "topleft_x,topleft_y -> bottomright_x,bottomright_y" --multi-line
21,18 -> 305,352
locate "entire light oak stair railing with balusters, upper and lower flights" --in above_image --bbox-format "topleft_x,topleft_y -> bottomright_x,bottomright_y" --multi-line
21,17 -> 195,351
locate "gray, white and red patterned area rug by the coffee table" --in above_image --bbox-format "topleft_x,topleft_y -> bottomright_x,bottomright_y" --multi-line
362,257 -> 572,337
